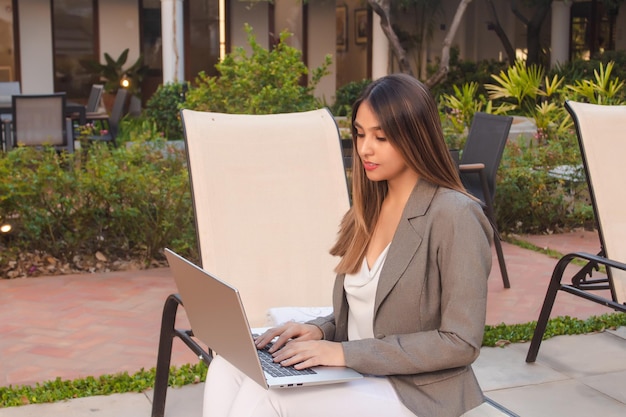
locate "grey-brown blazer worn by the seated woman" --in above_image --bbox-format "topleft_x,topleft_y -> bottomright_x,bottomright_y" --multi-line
310,180 -> 493,417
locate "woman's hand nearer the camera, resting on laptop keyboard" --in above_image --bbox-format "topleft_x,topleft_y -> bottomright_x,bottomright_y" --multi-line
273,340 -> 346,369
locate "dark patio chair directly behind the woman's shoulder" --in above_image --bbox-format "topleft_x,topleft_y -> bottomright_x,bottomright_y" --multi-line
459,112 -> 513,288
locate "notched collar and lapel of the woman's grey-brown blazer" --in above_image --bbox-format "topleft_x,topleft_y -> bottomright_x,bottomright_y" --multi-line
374,179 -> 438,316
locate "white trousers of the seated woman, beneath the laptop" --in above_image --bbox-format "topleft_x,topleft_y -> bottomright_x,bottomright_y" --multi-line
203,356 -> 415,417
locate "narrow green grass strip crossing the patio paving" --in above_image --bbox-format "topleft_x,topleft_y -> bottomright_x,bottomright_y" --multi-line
0,313 -> 626,408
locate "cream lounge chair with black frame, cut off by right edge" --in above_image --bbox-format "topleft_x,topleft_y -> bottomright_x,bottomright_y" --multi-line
526,101 -> 626,362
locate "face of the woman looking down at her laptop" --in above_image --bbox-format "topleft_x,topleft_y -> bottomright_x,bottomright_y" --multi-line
354,101 -> 416,182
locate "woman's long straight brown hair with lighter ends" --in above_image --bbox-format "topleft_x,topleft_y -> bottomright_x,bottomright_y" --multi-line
330,74 -> 473,273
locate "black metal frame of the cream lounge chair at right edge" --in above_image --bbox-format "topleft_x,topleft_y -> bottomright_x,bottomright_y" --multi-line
526,101 -> 626,363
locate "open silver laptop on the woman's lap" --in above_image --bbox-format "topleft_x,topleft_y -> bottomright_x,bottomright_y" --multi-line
165,249 -> 363,389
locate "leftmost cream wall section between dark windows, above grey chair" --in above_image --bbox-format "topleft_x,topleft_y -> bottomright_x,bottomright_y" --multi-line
18,0 -> 54,94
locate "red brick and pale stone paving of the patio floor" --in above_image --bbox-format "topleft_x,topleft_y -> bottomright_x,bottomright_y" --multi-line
0,231 -> 626,417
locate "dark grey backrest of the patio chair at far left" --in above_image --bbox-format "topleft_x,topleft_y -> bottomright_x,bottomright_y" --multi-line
8,93 -> 73,152
